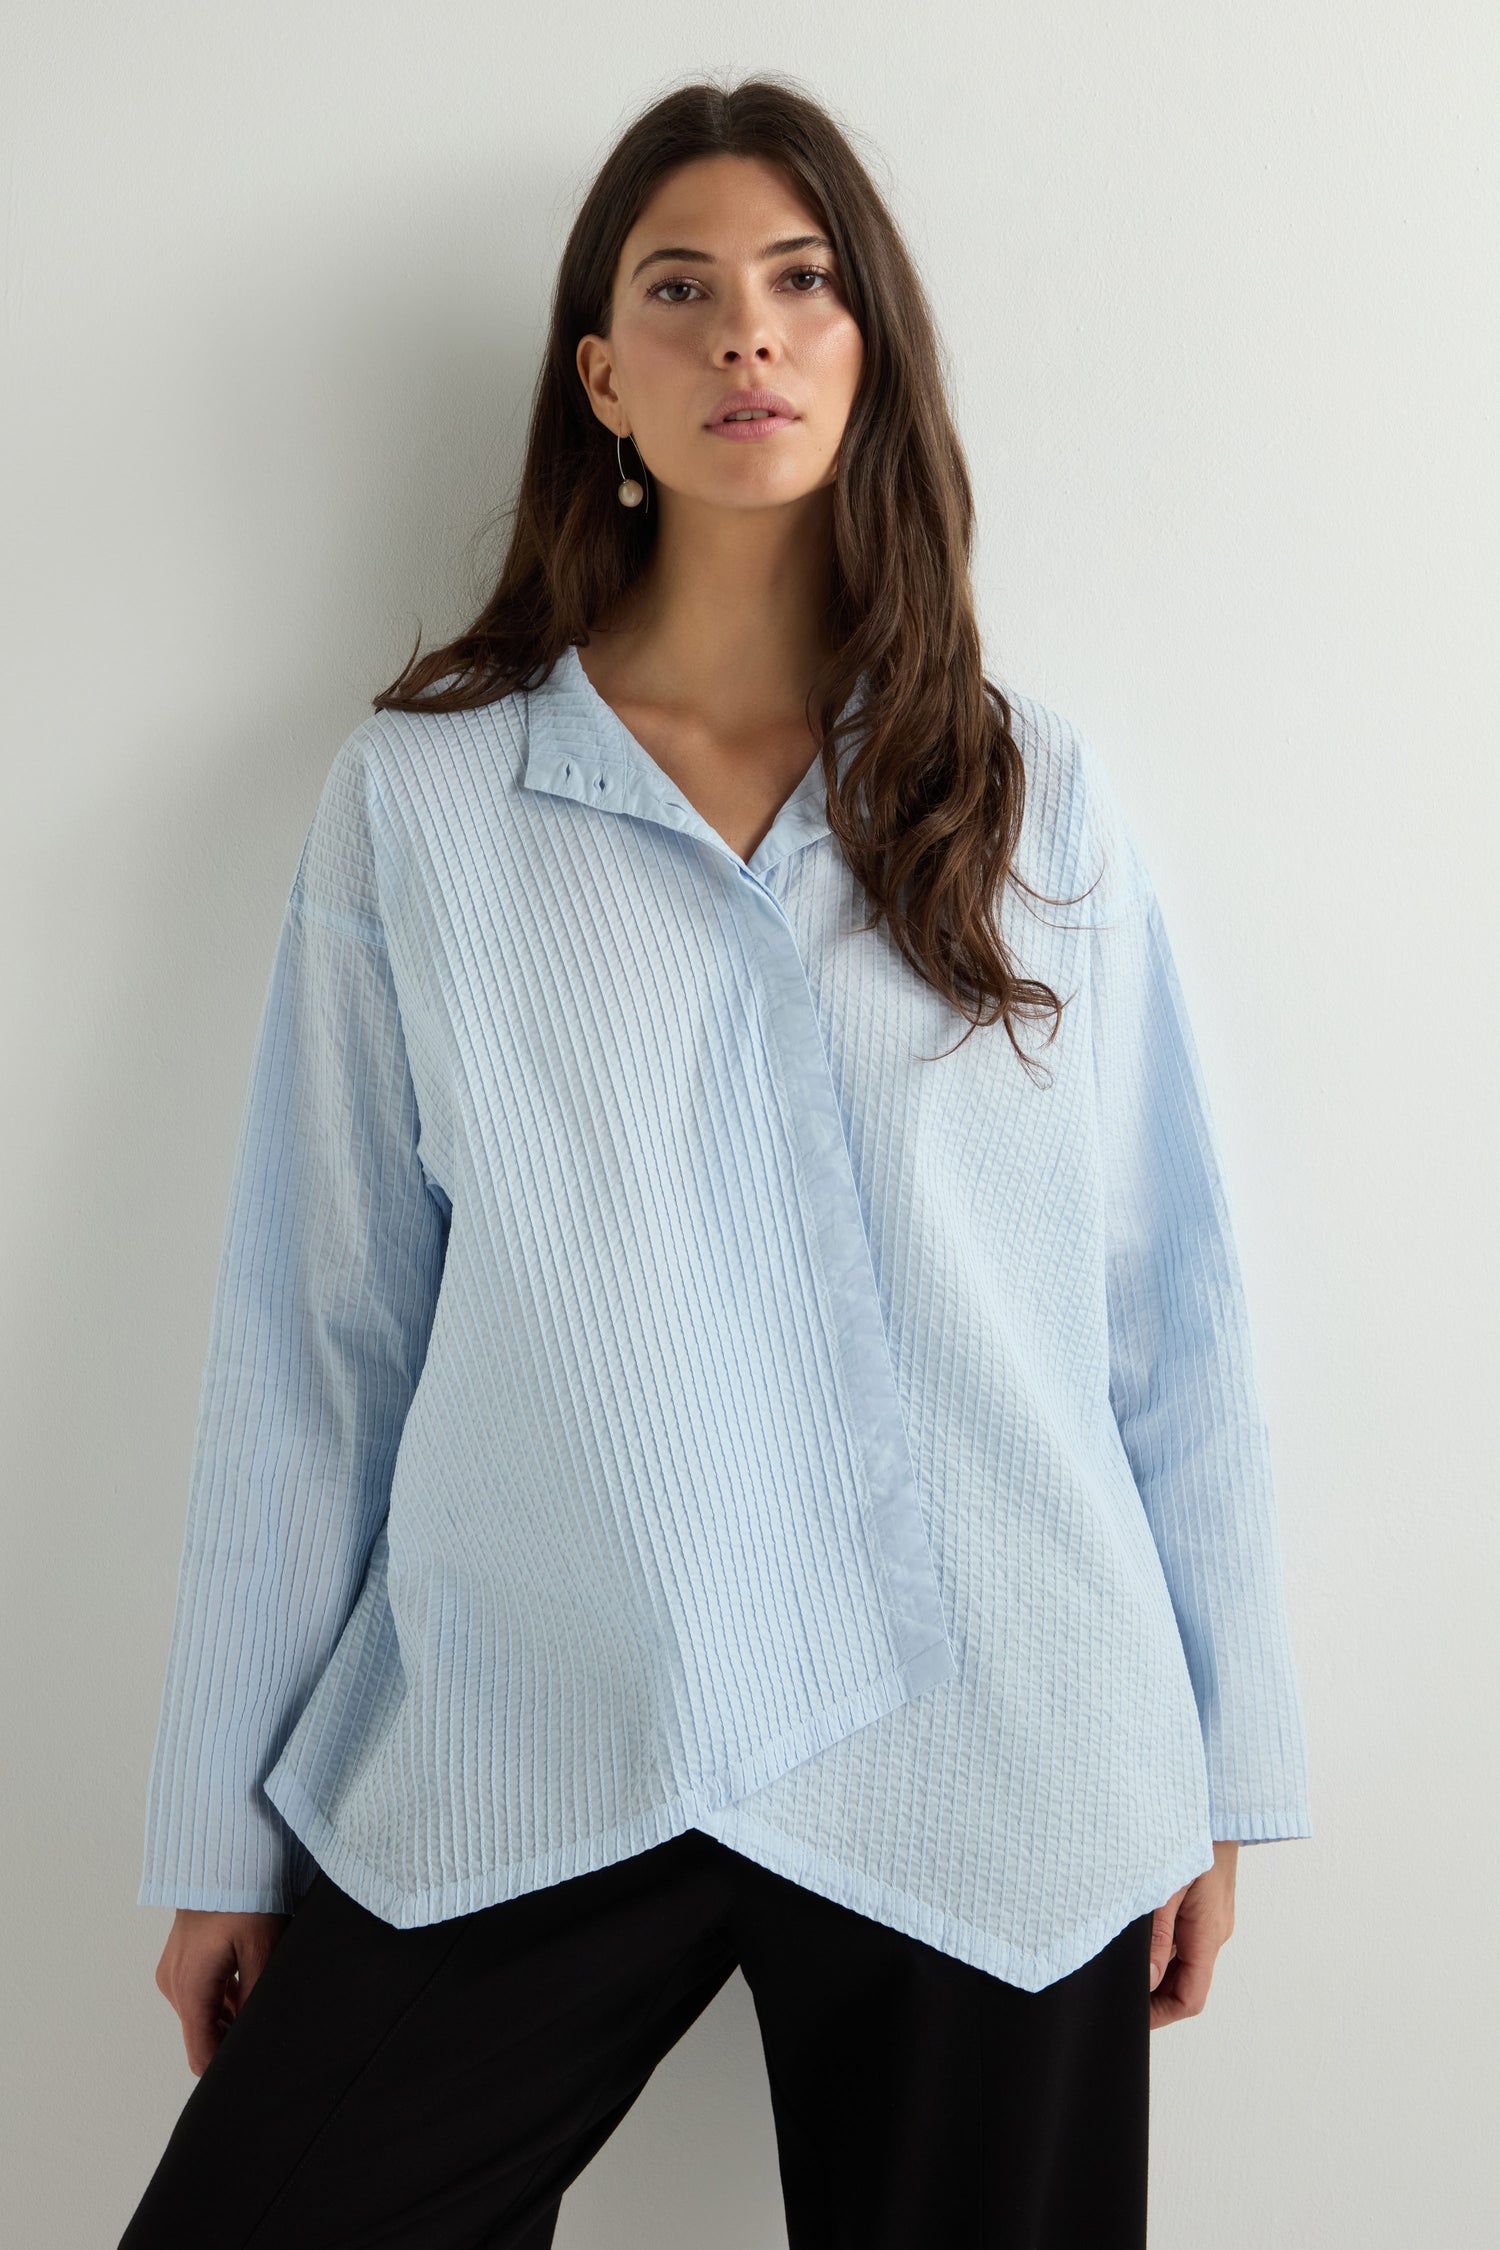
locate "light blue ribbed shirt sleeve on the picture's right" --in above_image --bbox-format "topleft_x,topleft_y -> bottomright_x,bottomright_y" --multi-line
1086,754 -> 1311,1843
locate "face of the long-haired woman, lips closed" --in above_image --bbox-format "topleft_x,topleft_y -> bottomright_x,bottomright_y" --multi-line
578,155 -> 864,509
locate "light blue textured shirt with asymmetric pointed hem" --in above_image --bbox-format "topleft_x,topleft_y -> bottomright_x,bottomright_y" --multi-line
139,648 -> 1311,1991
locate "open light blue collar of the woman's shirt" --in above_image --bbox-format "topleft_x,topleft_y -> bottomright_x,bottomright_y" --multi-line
522,644 -> 868,875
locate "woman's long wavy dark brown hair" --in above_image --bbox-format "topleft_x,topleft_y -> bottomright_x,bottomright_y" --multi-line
373,77 -> 1066,1069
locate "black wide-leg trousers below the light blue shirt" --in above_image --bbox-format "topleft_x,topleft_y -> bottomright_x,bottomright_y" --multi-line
119,1829 -> 1151,2250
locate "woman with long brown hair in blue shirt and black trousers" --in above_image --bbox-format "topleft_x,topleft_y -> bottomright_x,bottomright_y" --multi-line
124,81 -> 1309,2250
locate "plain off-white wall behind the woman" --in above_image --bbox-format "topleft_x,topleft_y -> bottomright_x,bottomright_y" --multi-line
0,0 -> 1500,2250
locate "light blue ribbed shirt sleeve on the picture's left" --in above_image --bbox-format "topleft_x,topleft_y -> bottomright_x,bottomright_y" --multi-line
137,731 -> 448,1913
